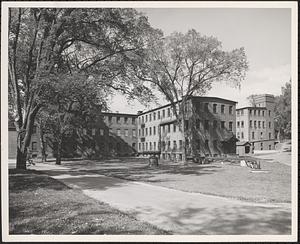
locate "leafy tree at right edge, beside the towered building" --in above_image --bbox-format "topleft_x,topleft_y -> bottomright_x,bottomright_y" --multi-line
274,80 -> 292,139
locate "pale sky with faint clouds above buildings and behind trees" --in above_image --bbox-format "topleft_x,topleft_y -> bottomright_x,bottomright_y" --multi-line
110,8 -> 291,114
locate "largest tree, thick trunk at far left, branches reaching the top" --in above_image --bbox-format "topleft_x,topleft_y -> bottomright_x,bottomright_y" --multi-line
8,8 -> 161,168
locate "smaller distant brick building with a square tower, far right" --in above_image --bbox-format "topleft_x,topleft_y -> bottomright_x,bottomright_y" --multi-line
236,94 -> 275,150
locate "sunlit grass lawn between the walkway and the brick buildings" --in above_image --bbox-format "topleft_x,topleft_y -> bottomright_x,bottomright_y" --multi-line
59,158 -> 291,203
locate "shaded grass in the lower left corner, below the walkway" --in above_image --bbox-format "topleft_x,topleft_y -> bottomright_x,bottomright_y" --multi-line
9,169 -> 168,235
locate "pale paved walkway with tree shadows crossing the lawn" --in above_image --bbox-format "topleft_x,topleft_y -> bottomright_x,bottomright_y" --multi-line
31,163 -> 291,235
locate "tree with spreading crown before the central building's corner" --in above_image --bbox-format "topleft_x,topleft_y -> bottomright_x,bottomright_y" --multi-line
132,30 -> 248,160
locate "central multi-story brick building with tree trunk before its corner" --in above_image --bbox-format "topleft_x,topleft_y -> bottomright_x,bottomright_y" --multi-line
138,97 -> 236,160
